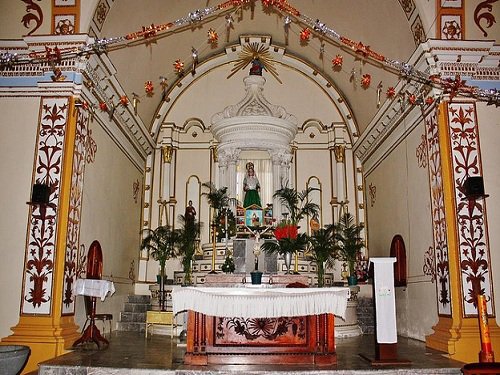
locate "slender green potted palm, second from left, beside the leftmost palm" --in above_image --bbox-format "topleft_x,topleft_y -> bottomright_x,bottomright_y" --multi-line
175,215 -> 202,285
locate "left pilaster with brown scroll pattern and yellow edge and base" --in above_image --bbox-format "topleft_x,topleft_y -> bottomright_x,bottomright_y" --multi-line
2,97 -> 81,371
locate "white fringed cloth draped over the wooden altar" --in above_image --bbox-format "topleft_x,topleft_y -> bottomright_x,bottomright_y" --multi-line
172,287 -> 349,318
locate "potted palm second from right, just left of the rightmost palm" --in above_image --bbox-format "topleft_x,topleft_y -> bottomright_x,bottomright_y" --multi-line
308,225 -> 336,288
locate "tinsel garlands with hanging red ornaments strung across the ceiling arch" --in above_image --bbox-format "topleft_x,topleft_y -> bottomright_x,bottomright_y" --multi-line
0,0 -> 500,110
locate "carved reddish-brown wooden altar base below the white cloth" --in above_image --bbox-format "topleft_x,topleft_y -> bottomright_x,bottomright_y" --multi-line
184,310 -> 337,365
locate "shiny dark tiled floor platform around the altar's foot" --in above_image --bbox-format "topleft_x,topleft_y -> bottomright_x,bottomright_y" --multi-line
34,332 -> 463,375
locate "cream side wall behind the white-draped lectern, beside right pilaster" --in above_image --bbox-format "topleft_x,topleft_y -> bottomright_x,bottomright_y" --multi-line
365,119 -> 437,340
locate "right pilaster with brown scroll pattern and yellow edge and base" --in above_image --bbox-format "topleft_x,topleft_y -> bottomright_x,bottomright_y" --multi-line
426,100 -> 500,362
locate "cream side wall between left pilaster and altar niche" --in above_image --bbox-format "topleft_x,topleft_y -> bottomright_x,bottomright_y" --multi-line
76,122 -> 143,325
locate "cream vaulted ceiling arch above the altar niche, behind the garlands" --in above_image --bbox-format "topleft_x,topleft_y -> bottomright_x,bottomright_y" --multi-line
92,0 -> 418,134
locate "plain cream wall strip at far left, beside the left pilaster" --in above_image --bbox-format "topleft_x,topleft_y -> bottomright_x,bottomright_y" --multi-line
0,98 -> 40,337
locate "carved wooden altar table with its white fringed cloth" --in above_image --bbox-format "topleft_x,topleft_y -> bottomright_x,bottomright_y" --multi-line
172,287 -> 349,365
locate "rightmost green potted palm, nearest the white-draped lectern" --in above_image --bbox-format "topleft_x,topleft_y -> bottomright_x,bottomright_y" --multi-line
334,212 -> 365,285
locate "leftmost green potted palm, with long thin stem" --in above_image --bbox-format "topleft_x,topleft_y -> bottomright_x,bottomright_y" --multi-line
141,225 -> 177,311
